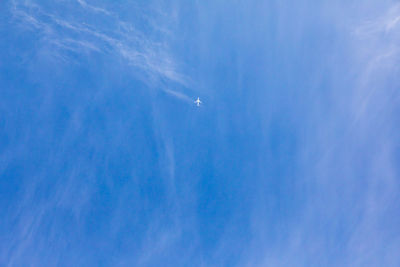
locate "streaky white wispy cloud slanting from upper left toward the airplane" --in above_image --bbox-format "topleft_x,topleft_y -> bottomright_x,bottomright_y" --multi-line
12,0 -> 187,89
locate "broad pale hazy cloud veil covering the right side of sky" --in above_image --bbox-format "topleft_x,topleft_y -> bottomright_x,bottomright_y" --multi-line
227,1 -> 400,266
